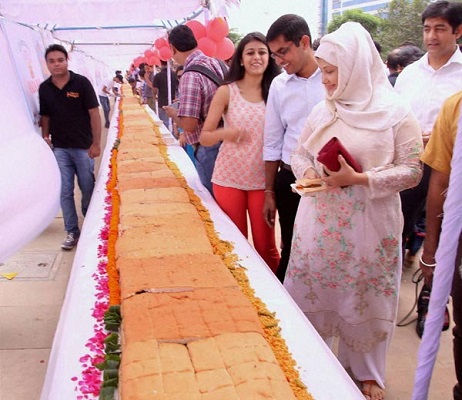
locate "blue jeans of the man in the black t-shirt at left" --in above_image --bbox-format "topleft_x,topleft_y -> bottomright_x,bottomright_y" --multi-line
53,147 -> 95,237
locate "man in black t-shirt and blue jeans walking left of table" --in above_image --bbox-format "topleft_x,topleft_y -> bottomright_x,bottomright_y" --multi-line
39,44 -> 101,250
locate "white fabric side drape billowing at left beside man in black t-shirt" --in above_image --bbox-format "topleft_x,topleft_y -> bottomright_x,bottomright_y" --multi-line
0,24 -> 61,262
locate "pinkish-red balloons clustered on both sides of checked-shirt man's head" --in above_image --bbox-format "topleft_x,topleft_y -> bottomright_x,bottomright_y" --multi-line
133,17 -> 234,67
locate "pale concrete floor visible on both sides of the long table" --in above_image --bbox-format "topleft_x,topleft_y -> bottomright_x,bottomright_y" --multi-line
0,115 -> 455,400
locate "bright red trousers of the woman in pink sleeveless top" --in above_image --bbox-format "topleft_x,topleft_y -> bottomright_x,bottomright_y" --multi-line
213,184 -> 280,272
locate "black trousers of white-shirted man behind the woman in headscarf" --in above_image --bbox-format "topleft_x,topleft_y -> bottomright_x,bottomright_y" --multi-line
399,164 -> 431,255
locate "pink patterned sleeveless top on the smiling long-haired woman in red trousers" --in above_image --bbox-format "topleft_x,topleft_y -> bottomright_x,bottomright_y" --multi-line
212,82 -> 266,190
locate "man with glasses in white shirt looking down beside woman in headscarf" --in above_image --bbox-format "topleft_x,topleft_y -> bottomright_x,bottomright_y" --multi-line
263,14 -> 325,282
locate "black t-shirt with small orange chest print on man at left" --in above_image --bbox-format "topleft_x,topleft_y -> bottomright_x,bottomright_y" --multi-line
39,71 -> 99,149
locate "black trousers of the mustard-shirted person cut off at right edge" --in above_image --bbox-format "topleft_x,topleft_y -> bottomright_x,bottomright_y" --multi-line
451,236 -> 462,400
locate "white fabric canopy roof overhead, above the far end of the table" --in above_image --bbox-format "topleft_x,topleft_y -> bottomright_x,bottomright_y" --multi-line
0,0 -> 239,69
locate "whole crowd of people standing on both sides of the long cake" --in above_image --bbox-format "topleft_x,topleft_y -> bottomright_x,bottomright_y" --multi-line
40,0 -> 462,400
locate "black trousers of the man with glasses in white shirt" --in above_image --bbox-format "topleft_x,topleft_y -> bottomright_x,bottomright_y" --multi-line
274,168 -> 300,282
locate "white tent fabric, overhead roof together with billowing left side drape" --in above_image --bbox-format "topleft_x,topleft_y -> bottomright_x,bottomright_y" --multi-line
0,0 -> 239,262
